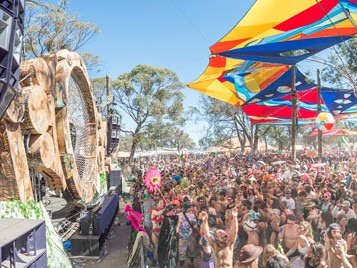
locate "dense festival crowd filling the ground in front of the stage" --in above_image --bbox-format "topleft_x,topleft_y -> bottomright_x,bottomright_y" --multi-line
121,152 -> 357,268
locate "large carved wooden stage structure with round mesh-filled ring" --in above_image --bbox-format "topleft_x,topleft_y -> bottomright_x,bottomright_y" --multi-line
0,50 -> 107,202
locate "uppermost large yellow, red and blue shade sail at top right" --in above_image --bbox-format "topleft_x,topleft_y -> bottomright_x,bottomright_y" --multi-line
210,0 -> 357,65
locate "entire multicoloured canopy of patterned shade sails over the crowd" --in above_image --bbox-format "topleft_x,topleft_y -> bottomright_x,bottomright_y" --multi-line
188,0 -> 357,123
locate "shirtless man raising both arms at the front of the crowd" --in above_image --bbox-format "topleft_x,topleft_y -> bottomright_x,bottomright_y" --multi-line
199,208 -> 238,268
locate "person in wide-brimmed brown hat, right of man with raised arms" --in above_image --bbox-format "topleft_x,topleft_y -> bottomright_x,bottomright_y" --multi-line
234,244 -> 263,268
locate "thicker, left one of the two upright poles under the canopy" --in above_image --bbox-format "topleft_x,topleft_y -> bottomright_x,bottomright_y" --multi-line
291,64 -> 297,165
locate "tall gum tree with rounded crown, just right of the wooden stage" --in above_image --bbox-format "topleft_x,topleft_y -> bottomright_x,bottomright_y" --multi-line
112,65 -> 185,160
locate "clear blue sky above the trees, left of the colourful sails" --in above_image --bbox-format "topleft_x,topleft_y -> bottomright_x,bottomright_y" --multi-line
67,0 -> 254,141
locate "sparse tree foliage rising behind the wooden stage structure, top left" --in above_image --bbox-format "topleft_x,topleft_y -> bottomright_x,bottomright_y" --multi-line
23,1 -> 100,69
